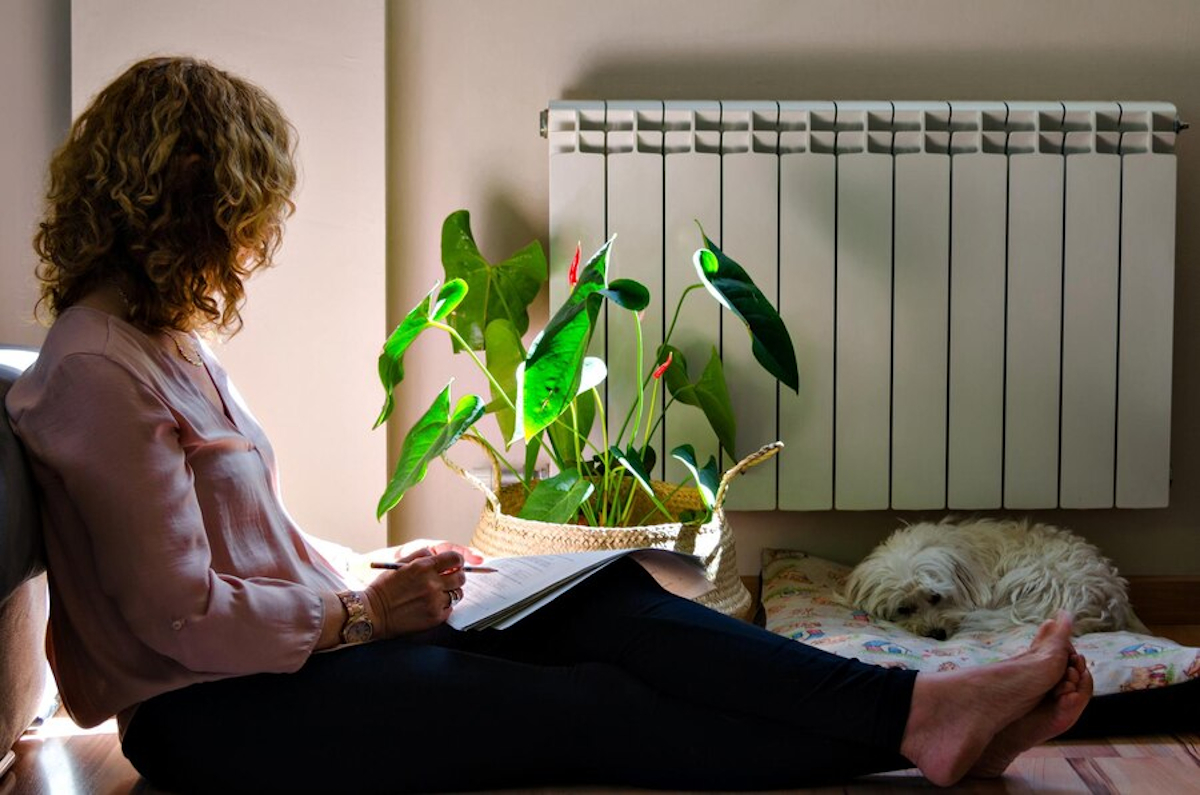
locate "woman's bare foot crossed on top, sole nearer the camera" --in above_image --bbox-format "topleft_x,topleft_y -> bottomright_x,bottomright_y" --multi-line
900,612 -> 1086,787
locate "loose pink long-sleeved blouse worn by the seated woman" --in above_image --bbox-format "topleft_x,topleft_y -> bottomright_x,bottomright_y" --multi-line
6,306 -> 346,729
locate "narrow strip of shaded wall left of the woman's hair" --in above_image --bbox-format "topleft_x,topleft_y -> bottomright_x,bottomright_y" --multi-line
0,0 -> 71,345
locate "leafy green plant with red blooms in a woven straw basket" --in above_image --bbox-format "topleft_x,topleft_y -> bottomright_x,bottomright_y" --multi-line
376,210 -> 799,614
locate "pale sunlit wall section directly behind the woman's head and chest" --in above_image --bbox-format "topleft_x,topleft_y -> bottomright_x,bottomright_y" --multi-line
71,0 -> 388,550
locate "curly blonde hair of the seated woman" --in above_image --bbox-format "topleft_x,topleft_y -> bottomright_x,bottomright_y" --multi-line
34,58 -> 296,334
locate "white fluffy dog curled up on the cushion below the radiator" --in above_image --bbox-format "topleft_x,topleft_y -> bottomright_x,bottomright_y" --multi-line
841,520 -> 1145,640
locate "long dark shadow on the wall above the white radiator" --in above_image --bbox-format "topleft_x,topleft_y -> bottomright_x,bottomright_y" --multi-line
556,48 -> 1200,106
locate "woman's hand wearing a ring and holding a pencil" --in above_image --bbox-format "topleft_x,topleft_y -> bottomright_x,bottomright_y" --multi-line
365,548 -> 467,639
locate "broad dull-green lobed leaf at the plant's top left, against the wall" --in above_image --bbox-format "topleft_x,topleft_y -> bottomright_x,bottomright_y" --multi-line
442,210 -> 547,351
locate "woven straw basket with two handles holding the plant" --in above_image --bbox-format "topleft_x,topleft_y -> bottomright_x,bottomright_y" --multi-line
443,436 -> 784,618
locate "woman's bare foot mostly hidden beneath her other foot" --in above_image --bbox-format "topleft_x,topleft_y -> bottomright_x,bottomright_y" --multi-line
967,654 -> 1092,778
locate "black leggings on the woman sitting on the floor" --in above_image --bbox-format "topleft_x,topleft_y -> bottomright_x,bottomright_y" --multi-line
122,561 -> 916,793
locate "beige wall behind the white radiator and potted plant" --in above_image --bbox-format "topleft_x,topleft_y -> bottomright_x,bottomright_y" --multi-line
388,0 -> 1200,574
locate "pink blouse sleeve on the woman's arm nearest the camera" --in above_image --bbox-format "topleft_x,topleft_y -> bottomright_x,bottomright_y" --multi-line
22,354 -> 324,675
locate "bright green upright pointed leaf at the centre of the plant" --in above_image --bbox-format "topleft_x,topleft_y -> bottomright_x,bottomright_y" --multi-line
518,240 -> 612,441
